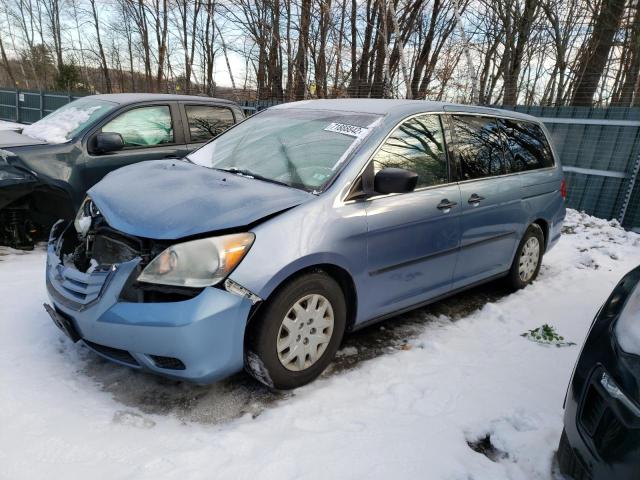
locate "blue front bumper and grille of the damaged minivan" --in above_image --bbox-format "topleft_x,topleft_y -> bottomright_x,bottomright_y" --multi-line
46,235 -> 252,383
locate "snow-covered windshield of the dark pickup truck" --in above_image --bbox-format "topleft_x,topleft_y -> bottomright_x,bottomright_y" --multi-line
22,97 -> 118,143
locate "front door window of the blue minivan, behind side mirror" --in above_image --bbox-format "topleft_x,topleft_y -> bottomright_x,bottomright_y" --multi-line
373,115 -> 449,188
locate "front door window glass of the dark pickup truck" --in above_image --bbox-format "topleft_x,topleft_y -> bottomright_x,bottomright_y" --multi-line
102,105 -> 174,147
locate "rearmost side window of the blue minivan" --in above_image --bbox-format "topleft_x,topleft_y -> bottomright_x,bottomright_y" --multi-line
498,118 -> 554,173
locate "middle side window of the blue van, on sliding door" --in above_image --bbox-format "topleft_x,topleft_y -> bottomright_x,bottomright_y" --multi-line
452,115 -> 504,180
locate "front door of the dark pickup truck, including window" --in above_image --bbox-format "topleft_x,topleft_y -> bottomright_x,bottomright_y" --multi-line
82,102 -> 188,190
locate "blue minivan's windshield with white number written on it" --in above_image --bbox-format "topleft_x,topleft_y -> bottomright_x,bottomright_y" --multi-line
187,108 -> 380,191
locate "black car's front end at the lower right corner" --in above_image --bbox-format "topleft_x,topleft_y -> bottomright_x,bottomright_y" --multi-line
558,268 -> 640,480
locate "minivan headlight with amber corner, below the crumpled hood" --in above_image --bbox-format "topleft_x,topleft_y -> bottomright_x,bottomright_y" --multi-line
138,233 -> 255,287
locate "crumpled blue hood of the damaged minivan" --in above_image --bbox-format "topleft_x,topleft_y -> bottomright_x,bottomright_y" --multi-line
88,160 -> 314,240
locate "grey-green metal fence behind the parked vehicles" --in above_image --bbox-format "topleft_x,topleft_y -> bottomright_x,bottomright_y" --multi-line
0,89 -> 640,230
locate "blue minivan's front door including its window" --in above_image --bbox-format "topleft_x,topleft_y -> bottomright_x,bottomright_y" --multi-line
362,114 -> 461,318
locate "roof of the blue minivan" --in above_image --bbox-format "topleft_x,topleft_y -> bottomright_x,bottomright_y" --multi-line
272,98 -> 540,122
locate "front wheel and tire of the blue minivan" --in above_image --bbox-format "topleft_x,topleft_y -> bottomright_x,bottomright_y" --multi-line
245,271 -> 347,390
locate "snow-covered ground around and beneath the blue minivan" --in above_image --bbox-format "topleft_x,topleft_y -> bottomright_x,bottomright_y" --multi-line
0,211 -> 640,480
